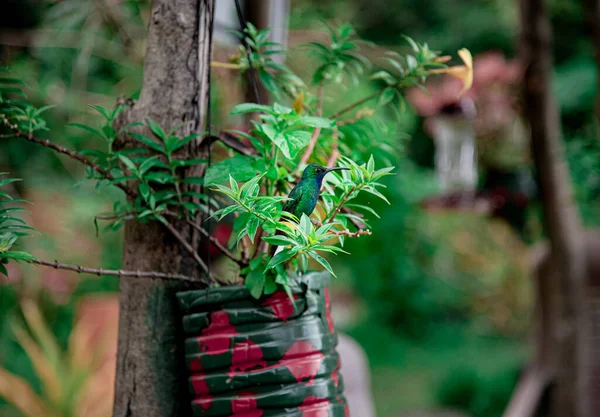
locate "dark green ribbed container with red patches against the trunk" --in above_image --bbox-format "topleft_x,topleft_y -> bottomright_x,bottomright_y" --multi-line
177,272 -> 349,417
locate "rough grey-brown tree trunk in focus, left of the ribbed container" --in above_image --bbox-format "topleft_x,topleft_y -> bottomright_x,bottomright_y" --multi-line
113,0 -> 214,417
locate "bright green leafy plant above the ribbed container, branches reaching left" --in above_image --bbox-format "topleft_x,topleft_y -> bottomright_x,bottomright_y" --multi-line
0,25 -> 472,297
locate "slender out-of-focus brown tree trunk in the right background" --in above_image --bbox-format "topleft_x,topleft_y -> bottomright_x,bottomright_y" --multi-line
520,0 -> 588,417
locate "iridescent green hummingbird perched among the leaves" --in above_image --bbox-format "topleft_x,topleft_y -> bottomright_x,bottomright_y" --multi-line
271,164 -> 349,256
